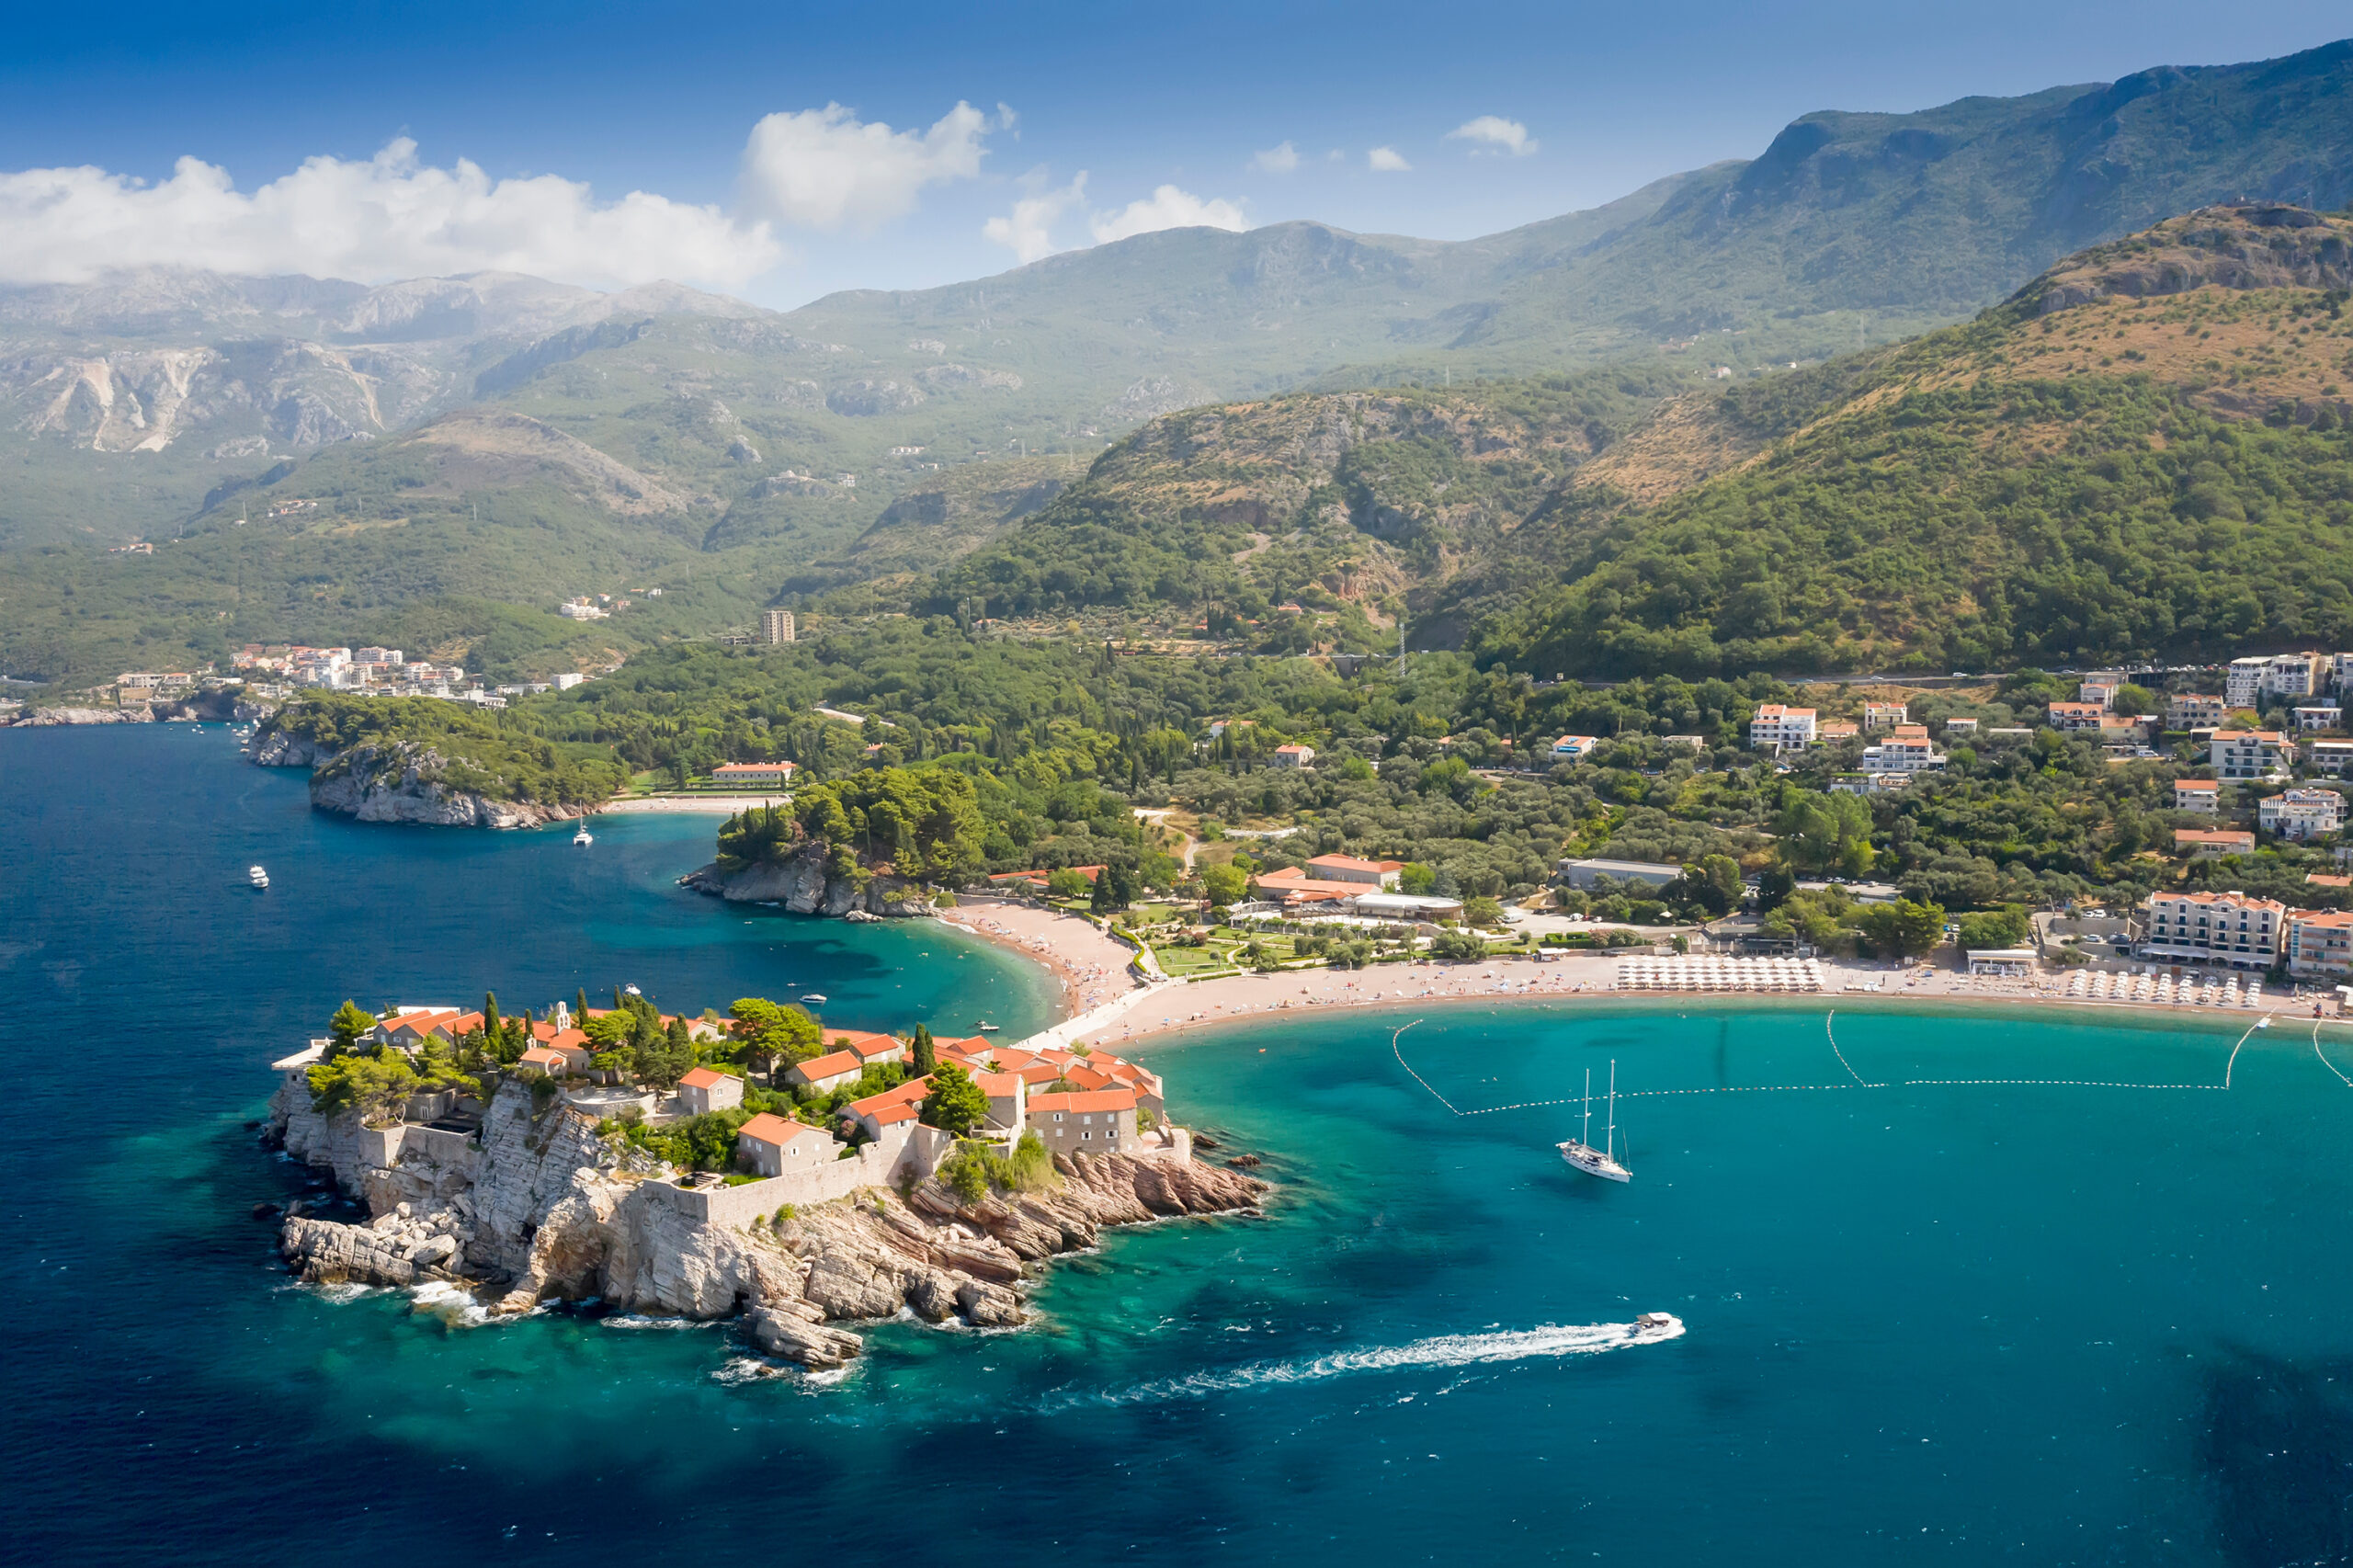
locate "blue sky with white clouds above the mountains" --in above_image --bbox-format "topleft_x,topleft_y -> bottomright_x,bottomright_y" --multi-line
0,0 -> 2353,306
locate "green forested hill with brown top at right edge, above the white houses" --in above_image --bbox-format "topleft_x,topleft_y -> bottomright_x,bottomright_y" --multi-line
1478,207 -> 2353,674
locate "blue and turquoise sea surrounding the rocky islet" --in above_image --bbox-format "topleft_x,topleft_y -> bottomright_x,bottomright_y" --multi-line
0,725 -> 2353,1568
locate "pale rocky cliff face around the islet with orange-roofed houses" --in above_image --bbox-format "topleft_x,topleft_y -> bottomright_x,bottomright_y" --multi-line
270,1081 -> 1266,1366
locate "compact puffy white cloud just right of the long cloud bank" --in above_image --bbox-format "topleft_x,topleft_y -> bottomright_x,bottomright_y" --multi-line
744,101 -> 993,233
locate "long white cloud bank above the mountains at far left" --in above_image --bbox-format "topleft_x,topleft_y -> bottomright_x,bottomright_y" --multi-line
0,139 -> 783,288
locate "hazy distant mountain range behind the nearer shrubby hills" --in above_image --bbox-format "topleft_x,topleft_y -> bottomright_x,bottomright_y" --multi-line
0,42 -> 2353,678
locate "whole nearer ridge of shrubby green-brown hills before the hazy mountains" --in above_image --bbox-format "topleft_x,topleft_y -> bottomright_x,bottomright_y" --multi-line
917,202 -> 2353,676
